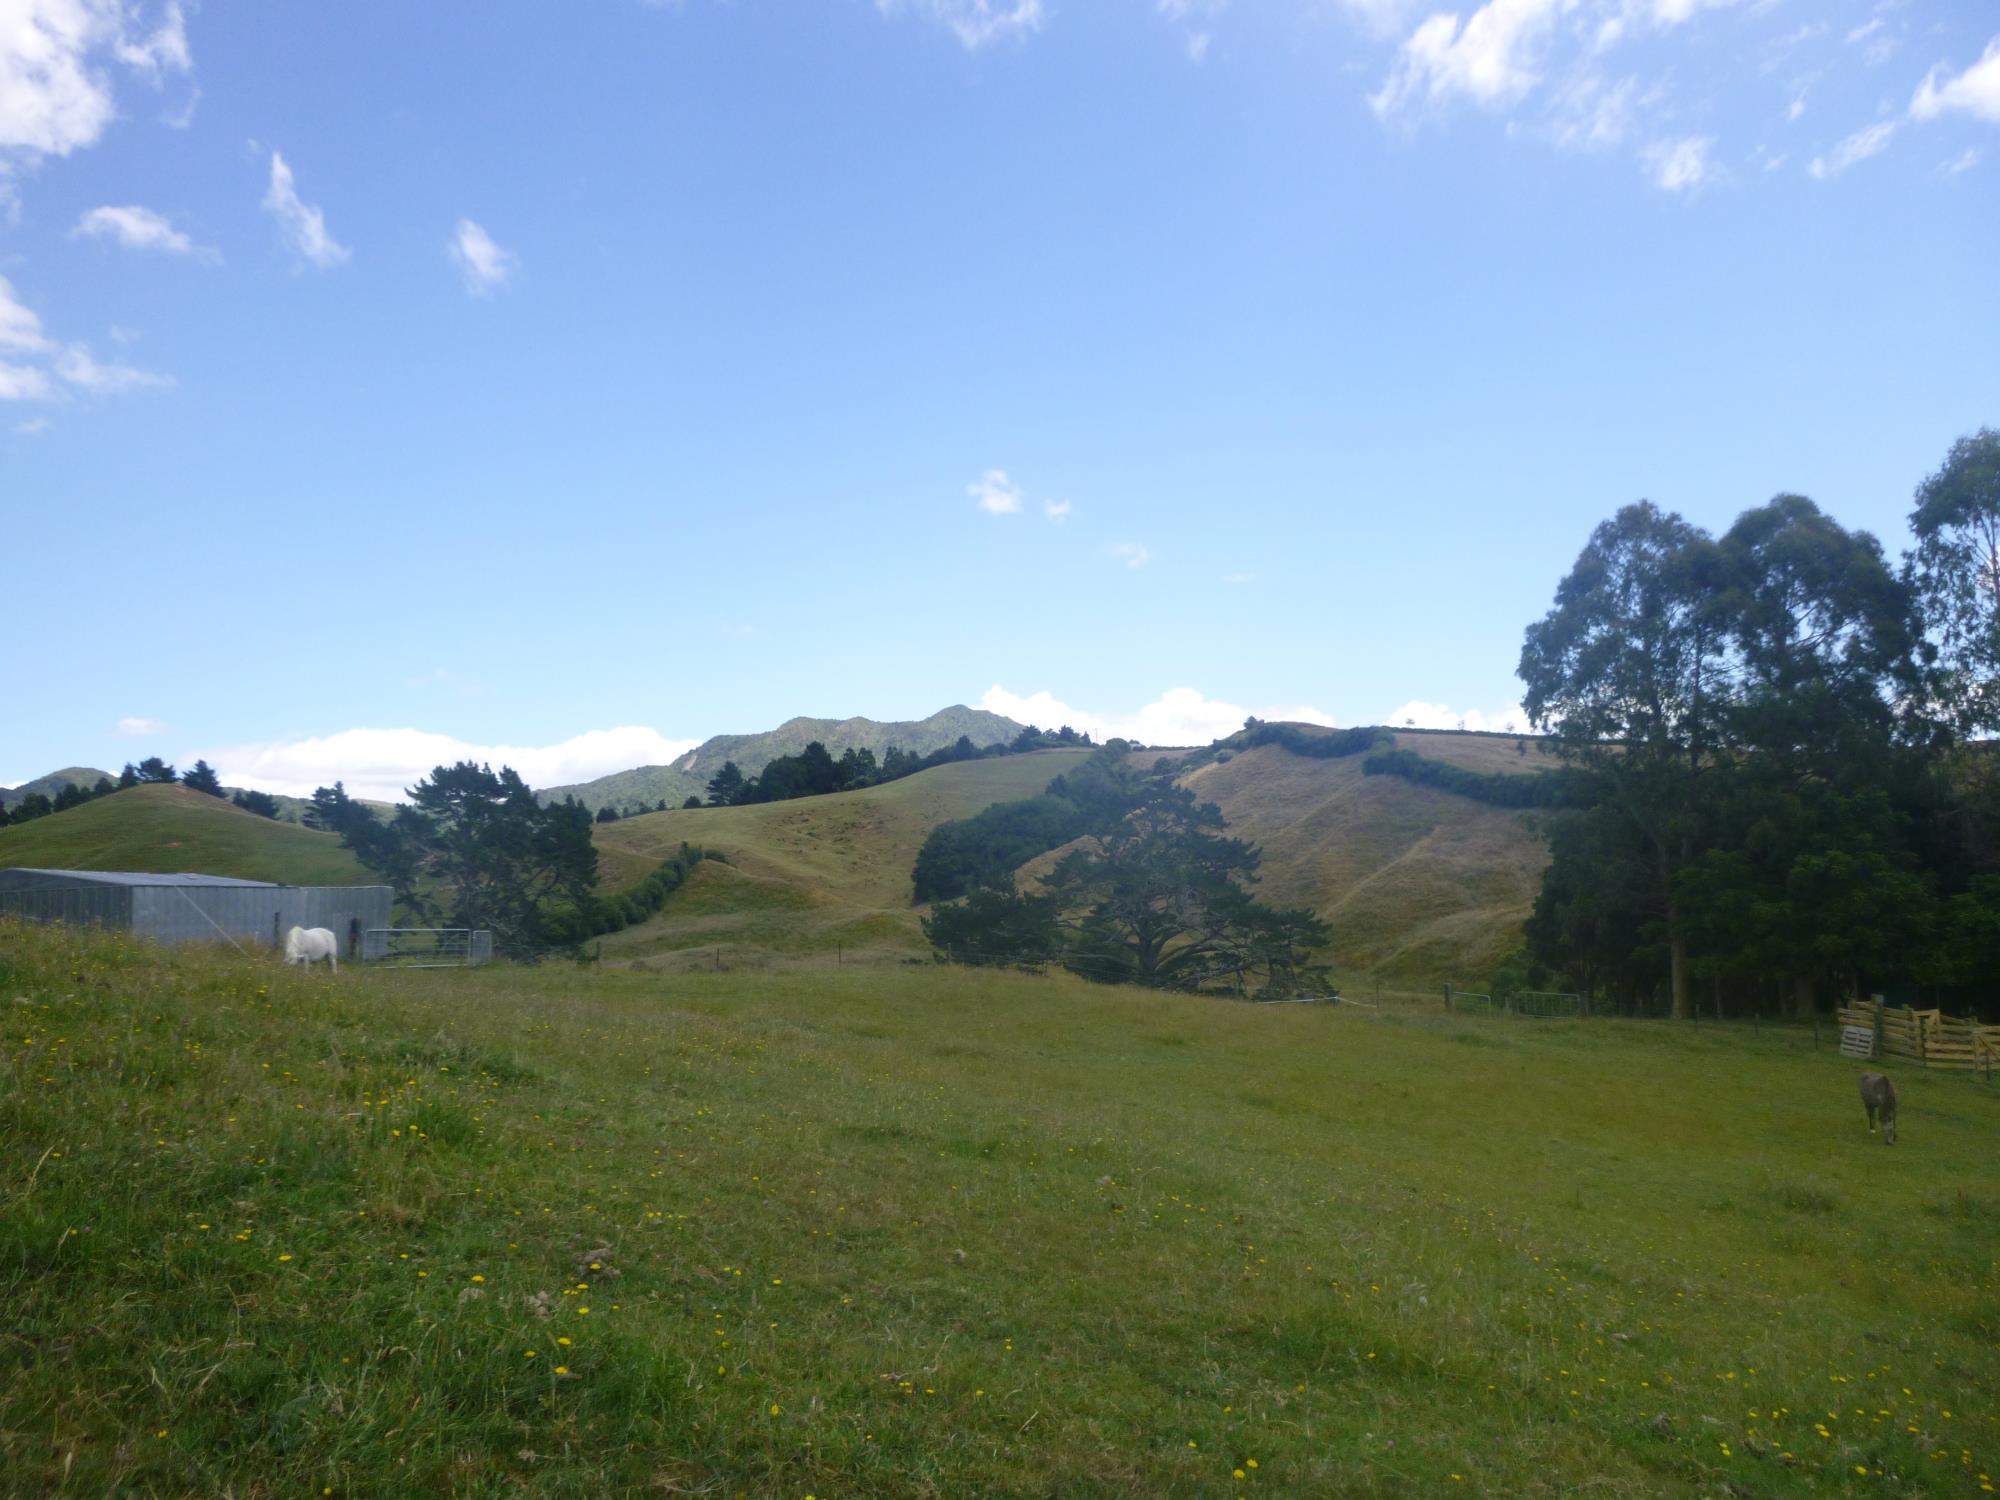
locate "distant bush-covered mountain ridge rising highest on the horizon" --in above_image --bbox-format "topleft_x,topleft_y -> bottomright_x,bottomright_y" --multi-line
536,704 -> 1024,812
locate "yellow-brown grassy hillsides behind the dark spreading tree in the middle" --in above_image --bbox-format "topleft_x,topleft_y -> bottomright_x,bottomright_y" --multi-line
598,730 -> 1554,984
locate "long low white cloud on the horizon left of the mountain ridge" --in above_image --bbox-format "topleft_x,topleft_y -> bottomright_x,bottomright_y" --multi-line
190,724 -> 700,802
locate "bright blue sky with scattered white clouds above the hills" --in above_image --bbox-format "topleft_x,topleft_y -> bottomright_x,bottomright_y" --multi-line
0,0 -> 2000,794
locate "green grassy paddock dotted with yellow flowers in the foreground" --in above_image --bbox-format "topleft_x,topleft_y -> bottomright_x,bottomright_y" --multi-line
0,928 -> 2000,1500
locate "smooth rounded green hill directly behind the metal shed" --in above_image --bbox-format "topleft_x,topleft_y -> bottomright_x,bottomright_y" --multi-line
0,786 -> 378,886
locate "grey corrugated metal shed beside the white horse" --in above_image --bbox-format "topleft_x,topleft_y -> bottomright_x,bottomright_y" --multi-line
0,868 -> 394,954
